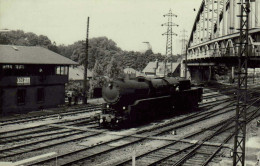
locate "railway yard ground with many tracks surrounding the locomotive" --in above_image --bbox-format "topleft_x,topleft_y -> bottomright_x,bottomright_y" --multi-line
0,83 -> 260,166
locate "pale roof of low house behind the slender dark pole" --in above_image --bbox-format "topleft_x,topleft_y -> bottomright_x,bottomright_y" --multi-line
69,66 -> 93,80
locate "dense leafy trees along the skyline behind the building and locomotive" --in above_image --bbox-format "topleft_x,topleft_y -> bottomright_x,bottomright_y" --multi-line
0,30 -> 181,87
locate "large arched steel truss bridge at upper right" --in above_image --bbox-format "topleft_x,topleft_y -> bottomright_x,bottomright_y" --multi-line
184,0 -> 260,81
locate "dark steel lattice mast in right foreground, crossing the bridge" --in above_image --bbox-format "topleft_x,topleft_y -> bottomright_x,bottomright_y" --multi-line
233,0 -> 250,166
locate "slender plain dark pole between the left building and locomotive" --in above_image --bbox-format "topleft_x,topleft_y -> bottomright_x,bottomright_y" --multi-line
83,17 -> 89,104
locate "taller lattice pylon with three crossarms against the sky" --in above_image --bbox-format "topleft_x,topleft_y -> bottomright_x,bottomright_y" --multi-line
162,9 -> 179,77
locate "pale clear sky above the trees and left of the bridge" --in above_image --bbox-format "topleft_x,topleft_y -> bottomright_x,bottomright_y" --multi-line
0,0 -> 202,54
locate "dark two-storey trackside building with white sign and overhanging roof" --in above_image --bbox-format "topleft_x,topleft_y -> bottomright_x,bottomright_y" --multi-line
0,45 -> 78,115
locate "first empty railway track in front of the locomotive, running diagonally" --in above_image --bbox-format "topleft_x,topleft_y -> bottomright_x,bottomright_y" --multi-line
22,94 -> 240,165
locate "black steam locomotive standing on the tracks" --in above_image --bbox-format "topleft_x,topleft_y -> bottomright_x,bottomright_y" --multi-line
99,77 -> 203,128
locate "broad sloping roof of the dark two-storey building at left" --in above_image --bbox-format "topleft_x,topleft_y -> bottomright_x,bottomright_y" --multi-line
0,45 -> 78,65
